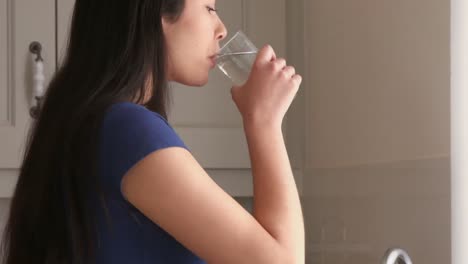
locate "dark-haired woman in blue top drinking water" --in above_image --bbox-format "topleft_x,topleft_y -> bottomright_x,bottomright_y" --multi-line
3,0 -> 304,264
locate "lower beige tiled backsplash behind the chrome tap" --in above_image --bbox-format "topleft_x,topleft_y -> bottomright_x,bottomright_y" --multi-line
303,158 -> 450,264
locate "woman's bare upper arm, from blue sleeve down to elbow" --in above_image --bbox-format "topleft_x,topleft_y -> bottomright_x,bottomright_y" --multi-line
122,147 -> 295,264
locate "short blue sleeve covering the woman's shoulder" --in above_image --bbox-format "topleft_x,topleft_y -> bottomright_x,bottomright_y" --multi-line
99,102 -> 188,197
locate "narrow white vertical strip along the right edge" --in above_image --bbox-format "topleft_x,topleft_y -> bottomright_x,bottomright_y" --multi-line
451,0 -> 468,264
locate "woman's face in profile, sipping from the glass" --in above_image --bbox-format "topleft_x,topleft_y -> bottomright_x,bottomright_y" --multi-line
162,0 -> 227,86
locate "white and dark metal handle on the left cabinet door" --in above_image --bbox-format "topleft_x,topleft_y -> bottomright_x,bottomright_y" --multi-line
29,41 -> 45,119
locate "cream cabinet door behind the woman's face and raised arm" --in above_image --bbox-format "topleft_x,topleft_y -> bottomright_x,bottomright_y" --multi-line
57,0 -> 286,169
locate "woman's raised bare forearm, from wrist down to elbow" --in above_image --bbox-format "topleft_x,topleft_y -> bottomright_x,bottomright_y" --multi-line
244,120 -> 305,263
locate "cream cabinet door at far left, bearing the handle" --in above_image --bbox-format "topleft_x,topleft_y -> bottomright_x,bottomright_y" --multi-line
0,0 -> 56,168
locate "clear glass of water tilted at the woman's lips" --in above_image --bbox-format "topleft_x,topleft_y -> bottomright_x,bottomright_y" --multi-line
216,31 -> 258,86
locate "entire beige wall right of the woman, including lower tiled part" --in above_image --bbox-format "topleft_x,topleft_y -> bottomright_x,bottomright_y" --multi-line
288,0 -> 450,264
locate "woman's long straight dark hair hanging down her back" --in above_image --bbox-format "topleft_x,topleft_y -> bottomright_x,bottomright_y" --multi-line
0,0 -> 185,264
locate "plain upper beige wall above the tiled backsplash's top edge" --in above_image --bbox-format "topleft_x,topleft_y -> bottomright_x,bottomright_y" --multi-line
305,0 -> 450,167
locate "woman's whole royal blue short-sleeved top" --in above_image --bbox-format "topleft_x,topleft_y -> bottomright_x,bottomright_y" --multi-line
96,102 -> 205,264
